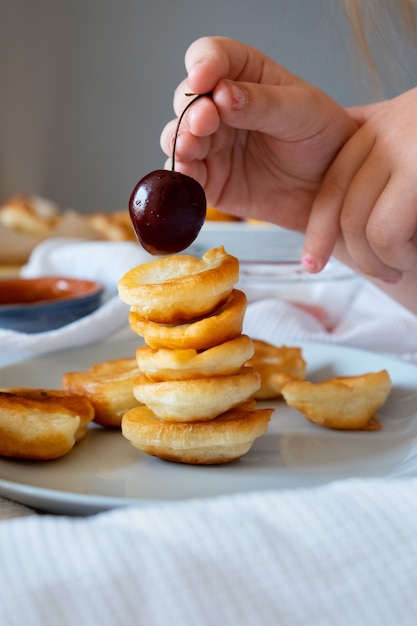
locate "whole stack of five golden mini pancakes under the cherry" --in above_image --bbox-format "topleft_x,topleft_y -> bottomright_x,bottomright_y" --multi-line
119,247 -> 272,464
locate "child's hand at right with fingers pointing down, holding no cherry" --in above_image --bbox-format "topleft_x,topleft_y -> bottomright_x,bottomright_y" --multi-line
304,89 -> 417,283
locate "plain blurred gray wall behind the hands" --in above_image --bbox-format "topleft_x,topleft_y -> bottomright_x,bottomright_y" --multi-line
0,0 -> 417,212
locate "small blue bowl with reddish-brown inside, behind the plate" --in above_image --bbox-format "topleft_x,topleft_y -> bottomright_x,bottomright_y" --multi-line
0,276 -> 104,333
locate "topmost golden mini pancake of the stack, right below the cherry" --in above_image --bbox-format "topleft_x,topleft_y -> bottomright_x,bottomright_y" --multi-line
118,247 -> 239,324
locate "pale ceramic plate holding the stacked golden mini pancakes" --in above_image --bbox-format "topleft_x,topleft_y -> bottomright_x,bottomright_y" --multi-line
0,340 -> 417,514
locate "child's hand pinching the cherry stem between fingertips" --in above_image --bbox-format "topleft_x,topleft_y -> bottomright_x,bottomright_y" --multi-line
161,37 -> 357,231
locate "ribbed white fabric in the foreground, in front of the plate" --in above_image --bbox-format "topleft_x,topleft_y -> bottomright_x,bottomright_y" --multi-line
0,480 -> 417,626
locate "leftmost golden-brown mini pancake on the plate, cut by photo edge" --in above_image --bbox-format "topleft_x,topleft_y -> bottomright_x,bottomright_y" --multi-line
0,387 -> 94,460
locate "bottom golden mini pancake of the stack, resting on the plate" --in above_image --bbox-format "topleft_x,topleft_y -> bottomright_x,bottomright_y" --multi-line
122,400 -> 272,465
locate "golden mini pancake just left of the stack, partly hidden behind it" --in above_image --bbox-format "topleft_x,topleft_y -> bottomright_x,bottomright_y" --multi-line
61,357 -> 139,428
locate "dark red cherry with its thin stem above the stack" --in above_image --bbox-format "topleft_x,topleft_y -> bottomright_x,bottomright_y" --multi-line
129,94 -> 210,255
